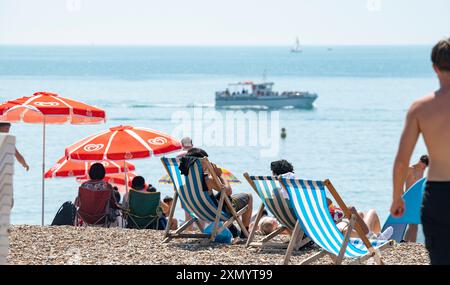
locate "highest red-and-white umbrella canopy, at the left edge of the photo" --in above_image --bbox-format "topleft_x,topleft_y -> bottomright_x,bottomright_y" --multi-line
0,92 -> 106,124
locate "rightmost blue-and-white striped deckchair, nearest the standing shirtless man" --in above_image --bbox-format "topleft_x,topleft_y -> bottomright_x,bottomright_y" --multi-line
279,178 -> 393,264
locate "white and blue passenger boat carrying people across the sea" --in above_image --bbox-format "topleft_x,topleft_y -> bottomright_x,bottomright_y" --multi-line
216,81 -> 318,109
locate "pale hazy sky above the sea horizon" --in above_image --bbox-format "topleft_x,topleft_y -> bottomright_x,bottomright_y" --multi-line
0,0 -> 450,46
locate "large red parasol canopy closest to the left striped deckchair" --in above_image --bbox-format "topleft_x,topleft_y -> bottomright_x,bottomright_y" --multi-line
66,126 -> 181,160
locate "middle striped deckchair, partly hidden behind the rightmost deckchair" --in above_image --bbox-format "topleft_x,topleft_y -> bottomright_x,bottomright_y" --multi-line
244,173 -> 310,250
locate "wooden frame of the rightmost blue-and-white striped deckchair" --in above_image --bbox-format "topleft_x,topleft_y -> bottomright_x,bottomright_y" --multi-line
278,179 -> 394,265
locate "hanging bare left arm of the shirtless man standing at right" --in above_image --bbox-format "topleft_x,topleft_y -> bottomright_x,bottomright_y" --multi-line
391,103 -> 420,217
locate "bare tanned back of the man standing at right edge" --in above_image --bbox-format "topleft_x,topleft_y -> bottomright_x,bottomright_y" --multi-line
411,89 -> 450,181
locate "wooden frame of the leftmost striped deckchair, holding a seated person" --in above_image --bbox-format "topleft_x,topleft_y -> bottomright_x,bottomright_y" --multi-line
161,157 -> 248,243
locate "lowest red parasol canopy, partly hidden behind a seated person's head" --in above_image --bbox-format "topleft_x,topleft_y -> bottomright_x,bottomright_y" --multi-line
45,157 -> 136,178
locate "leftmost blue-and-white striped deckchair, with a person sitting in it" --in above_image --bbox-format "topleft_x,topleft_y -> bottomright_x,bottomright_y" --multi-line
161,157 -> 248,242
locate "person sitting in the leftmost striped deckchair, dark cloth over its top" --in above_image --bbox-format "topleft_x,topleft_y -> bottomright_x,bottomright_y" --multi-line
180,148 -> 253,238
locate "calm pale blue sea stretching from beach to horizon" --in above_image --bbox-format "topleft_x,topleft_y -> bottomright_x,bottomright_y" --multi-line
0,46 -> 438,240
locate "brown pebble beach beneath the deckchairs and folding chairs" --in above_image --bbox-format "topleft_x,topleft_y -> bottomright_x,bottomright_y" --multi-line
8,225 -> 429,265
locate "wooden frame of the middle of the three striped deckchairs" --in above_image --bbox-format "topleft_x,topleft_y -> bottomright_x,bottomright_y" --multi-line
244,172 -> 311,250
